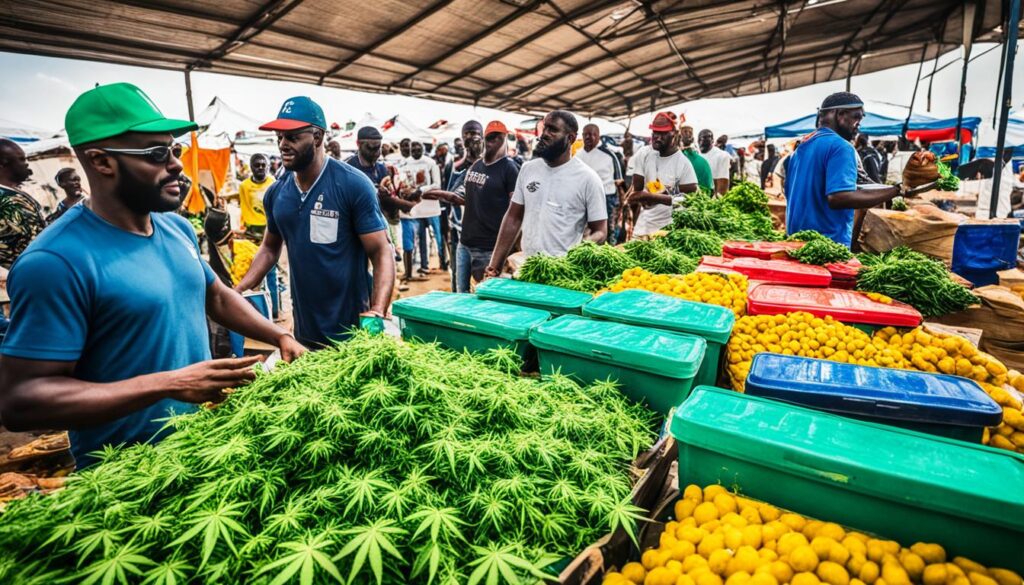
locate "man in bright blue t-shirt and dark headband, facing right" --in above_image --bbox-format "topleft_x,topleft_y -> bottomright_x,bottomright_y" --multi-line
785,91 -> 900,248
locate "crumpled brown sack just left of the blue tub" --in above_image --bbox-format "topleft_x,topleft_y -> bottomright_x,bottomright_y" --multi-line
859,205 -> 967,265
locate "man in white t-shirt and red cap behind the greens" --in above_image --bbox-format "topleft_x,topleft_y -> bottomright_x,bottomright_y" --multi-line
630,112 -> 697,237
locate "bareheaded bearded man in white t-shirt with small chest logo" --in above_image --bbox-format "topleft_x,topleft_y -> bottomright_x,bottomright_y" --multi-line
484,110 -> 608,278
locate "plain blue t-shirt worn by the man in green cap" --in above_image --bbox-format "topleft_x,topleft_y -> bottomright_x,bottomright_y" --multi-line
0,205 -> 215,467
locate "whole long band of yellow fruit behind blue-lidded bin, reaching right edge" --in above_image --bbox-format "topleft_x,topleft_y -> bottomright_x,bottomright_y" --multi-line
726,312 -> 1024,453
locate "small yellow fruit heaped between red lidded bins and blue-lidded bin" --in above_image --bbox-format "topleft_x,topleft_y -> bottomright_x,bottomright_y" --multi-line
726,312 -> 910,391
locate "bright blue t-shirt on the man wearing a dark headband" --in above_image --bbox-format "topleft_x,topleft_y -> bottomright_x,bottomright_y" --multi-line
785,128 -> 857,248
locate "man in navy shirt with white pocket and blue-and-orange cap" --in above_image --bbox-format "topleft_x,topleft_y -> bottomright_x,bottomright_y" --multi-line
236,97 -> 394,346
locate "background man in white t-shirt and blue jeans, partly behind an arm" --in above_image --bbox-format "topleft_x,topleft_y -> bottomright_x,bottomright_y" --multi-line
398,142 -> 447,280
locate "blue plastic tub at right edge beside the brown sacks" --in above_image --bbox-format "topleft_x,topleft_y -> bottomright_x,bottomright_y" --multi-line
952,221 -> 1021,287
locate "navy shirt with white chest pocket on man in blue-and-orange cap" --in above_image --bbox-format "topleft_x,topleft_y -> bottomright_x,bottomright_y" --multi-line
263,159 -> 387,346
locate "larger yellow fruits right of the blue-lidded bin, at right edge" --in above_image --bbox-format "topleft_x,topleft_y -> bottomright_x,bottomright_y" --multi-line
874,327 -> 1024,453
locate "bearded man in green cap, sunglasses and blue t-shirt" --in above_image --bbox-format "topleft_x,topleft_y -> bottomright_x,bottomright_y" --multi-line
0,83 -> 304,467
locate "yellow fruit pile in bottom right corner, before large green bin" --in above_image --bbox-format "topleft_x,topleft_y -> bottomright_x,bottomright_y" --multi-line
604,485 -> 1021,585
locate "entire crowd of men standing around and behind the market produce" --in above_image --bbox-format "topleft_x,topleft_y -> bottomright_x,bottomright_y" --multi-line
0,83 -> 1015,466
